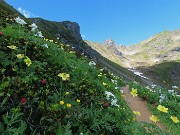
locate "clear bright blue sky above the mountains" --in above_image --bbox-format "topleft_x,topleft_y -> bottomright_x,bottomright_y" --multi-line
5,0 -> 180,45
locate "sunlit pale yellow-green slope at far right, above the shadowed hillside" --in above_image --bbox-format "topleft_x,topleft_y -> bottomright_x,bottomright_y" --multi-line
120,31 -> 180,66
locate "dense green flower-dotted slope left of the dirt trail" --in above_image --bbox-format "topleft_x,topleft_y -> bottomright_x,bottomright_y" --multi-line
0,3 -> 166,135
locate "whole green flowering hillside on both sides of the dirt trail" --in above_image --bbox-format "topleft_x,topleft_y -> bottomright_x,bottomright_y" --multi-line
0,1 -> 180,135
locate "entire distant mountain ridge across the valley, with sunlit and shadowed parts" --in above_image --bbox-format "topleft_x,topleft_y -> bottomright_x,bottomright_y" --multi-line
86,30 -> 180,88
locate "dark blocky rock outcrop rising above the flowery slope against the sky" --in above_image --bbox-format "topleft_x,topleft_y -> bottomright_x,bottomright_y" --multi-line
31,18 -> 82,43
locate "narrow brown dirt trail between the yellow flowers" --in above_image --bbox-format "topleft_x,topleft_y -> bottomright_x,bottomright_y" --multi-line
122,86 -> 165,130
